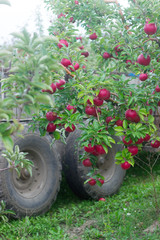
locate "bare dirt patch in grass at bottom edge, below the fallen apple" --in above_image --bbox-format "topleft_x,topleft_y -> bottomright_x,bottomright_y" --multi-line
68,220 -> 96,240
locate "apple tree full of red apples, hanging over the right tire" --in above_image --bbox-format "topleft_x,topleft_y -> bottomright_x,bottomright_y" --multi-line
5,0 -> 160,186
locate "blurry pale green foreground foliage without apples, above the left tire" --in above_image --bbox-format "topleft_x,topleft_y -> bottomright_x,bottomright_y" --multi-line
0,29 -> 58,151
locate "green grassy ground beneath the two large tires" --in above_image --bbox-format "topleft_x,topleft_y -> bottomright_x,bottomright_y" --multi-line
0,153 -> 160,240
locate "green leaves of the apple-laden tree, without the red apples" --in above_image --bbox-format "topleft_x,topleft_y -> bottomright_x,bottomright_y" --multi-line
37,0 -> 160,182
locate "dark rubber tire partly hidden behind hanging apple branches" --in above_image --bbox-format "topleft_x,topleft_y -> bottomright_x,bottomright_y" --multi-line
64,130 -> 125,200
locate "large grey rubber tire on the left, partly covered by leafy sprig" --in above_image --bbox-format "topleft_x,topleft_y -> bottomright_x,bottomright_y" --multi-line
0,127 -> 61,218
